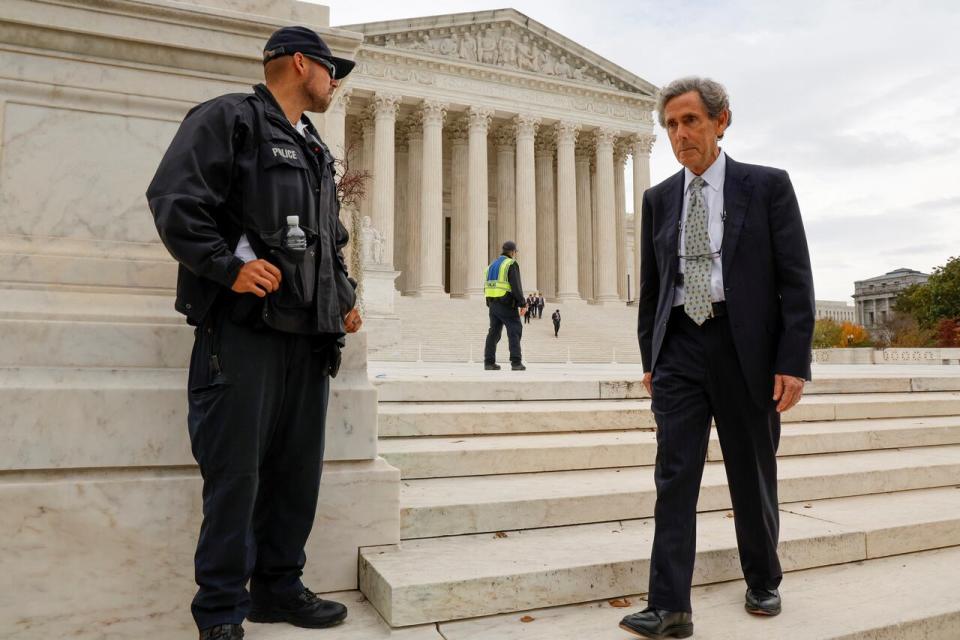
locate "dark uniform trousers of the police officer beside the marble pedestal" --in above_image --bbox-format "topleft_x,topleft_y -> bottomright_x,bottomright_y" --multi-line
187,304 -> 329,629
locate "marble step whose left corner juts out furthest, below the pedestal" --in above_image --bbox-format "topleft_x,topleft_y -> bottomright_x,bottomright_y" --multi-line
360,484 -> 960,624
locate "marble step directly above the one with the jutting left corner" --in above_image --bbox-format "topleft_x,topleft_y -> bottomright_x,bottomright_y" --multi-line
400,445 -> 960,539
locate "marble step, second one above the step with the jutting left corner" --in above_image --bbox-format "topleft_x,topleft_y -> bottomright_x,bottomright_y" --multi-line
379,416 -> 960,479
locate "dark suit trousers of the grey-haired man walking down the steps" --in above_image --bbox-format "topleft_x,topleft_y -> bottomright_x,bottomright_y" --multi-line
647,307 -> 783,611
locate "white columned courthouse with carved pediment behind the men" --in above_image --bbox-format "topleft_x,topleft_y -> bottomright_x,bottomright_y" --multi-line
323,9 -> 656,303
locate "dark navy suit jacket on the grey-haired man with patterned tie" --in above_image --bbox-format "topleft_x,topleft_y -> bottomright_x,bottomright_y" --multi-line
637,156 -> 815,405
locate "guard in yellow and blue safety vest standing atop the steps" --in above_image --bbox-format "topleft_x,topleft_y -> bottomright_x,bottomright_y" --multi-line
483,240 -> 527,371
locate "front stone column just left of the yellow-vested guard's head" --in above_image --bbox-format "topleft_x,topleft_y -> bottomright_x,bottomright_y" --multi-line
466,107 -> 493,297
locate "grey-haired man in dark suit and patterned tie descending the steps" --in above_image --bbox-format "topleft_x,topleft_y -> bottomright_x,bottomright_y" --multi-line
620,78 -> 814,638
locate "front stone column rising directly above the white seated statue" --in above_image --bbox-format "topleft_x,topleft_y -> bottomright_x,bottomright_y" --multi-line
371,93 -> 400,269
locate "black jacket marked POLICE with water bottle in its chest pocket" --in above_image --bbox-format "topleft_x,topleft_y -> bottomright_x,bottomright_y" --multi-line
147,84 -> 355,336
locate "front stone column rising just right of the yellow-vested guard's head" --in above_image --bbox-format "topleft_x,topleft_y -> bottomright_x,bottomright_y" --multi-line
513,115 -> 540,292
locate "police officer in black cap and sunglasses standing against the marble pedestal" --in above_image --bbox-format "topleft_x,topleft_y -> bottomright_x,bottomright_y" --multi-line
147,27 -> 361,640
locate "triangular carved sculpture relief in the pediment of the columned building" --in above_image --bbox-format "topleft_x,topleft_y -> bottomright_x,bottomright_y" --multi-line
367,22 -> 637,93
